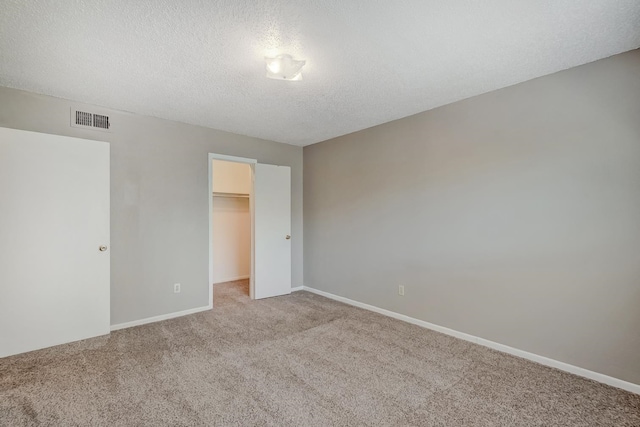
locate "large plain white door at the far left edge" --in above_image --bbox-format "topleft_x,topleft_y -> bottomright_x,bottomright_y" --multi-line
0,128 -> 110,357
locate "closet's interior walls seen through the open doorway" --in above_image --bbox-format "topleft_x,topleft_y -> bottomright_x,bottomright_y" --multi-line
212,160 -> 251,283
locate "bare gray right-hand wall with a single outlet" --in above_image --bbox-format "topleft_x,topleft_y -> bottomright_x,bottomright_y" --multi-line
304,51 -> 640,383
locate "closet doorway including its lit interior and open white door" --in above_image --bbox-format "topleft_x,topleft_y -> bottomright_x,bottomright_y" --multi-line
209,153 -> 292,304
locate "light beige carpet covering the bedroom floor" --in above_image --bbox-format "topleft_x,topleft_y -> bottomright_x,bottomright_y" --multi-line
0,282 -> 640,426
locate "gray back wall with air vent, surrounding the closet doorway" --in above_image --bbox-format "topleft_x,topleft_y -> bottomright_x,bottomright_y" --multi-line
0,87 -> 302,324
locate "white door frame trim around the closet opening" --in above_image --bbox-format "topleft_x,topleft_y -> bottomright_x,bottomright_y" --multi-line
207,153 -> 258,308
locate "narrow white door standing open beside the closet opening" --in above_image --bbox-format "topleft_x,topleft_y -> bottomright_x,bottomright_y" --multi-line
254,163 -> 291,299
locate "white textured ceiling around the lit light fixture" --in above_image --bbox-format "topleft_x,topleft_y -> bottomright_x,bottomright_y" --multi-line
0,0 -> 640,145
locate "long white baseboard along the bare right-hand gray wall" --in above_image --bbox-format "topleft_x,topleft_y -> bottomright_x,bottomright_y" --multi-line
302,286 -> 640,394
